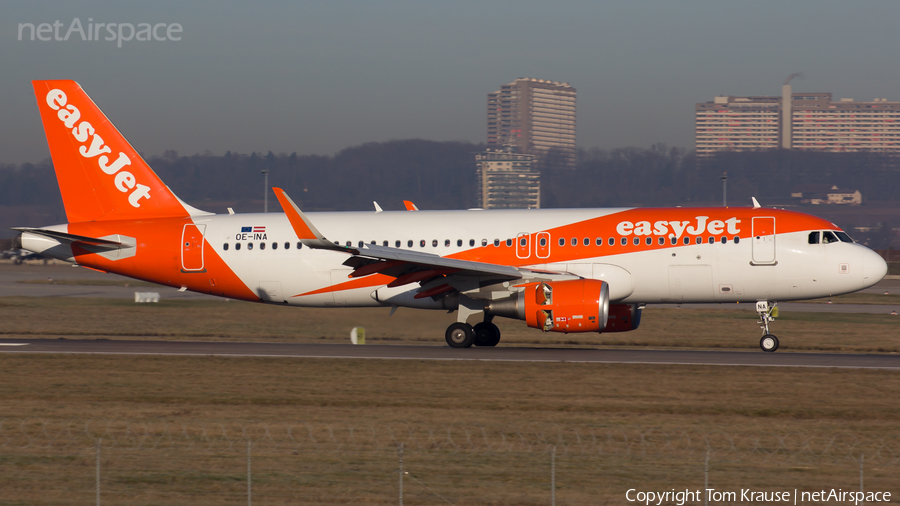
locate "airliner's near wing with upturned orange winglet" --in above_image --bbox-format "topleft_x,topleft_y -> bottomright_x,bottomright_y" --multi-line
273,188 -> 577,296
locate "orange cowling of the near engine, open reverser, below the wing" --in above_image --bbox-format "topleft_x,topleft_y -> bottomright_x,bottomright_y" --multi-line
524,279 -> 609,332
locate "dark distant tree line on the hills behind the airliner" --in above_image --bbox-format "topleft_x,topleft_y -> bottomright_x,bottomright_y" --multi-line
0,140 -> 900,212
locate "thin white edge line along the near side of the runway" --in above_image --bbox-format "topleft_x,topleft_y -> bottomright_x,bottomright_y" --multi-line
0,351 -> 900,371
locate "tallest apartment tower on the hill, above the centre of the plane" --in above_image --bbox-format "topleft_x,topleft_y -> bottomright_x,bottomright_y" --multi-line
487,78 -> 576,163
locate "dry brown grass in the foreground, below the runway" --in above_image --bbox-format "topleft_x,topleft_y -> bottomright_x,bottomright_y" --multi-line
0,355 -> 900,504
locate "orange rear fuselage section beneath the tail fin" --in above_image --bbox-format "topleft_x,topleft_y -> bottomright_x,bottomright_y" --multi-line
69,218 -> 260,302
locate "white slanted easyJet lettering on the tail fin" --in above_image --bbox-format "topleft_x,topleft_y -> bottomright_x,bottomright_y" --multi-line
47,89 -> 150,207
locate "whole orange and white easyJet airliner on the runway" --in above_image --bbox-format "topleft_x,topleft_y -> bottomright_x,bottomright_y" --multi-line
16,80 -> 887,352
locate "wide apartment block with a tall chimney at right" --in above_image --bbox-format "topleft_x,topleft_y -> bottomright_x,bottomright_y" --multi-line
695,84 -> 900,156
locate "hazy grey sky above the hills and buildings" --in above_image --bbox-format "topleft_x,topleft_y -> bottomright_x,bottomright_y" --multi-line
0,0 -> 900,163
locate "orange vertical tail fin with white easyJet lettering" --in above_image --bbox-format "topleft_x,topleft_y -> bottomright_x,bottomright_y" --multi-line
32,80 -> 196,222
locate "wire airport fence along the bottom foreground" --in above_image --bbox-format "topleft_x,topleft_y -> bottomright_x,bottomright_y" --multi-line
0,418 -> 900,504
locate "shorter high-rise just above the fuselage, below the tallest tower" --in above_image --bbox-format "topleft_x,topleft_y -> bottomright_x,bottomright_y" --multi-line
475,146 -> 541,209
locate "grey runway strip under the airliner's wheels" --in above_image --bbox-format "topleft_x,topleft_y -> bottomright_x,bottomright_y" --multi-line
0,339 -> 900,370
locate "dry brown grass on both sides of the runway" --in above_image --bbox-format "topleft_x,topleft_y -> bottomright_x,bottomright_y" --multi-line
0,298 -> 900,505
